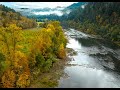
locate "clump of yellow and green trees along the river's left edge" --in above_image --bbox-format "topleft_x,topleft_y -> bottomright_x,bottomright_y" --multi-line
31,21 -> 67,72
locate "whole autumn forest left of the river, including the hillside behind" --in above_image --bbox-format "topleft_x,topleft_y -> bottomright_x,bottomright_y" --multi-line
0,5 -> 67,88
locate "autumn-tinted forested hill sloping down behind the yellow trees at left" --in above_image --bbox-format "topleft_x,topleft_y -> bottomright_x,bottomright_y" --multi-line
0,5 -> 37,29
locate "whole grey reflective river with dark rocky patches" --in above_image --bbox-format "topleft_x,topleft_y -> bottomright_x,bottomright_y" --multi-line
58,29 -> 120,88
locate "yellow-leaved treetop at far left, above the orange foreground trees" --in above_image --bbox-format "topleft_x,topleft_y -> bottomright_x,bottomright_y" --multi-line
0,24 -> 21,63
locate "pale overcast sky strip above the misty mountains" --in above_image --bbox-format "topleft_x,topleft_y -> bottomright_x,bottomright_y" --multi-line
0,2 -> 77,8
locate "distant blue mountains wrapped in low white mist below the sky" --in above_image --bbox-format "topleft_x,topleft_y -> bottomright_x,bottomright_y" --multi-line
9,2 -> 86,21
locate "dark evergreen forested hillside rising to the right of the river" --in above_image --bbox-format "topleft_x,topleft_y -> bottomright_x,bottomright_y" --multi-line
62,2 -> 120,43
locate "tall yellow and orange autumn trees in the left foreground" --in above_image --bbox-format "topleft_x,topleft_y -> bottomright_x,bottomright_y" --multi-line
0,24 -> 30,87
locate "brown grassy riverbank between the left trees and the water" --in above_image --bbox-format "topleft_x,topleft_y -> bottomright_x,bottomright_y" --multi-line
28,53 -> 70,88
